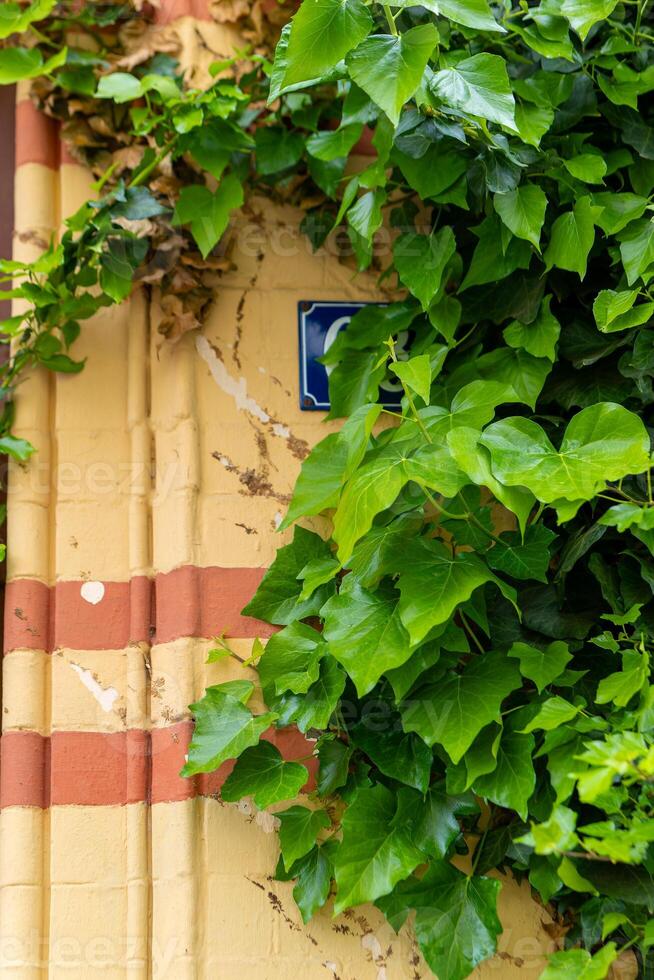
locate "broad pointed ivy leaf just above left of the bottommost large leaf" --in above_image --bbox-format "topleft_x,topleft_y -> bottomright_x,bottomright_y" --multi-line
334,784 -> 423,914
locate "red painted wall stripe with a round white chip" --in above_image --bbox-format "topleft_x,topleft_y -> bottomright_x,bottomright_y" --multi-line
4,565 -> 275,652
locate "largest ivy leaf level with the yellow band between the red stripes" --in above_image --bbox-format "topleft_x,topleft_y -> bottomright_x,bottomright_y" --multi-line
401,653 -> 520,763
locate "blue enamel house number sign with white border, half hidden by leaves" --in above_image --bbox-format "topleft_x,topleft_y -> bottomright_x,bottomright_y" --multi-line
298,300 -> 402,412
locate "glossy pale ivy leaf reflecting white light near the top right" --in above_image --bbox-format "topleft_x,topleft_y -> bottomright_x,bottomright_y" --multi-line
430,54 -> 516,132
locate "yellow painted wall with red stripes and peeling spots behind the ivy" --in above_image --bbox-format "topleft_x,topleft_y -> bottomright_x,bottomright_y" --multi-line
0,11 -> 564,980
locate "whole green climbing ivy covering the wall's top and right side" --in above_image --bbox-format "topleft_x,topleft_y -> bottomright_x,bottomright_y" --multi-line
0,0 -> 654,980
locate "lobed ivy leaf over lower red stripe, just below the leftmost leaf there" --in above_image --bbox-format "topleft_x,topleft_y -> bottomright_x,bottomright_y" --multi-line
221,742 -> 309,810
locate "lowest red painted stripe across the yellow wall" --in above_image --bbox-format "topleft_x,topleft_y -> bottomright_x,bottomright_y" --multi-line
0,721 -> 315,809
